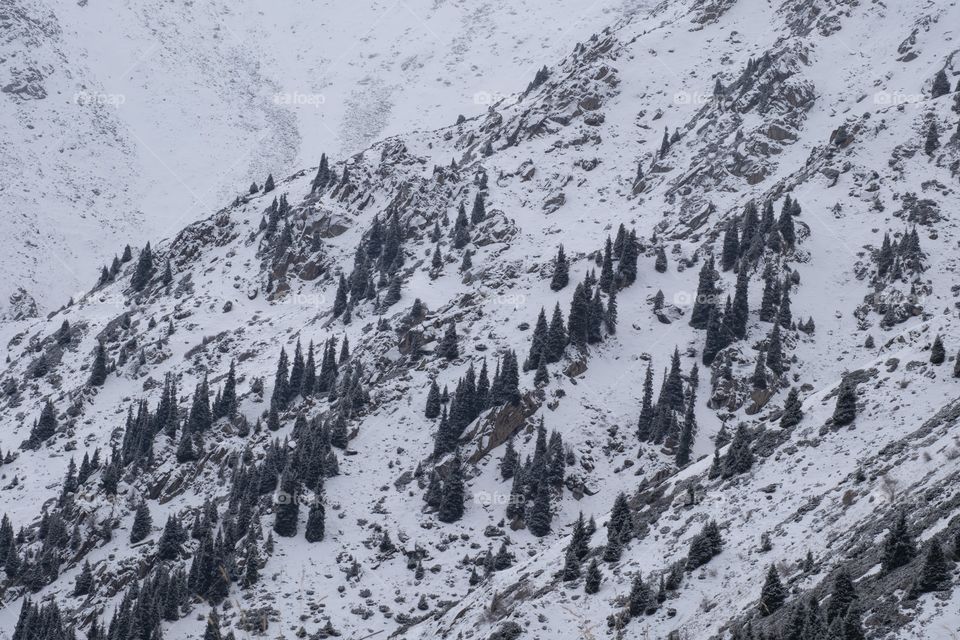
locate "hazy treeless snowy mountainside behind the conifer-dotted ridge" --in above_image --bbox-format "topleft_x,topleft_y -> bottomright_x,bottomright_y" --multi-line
0,0 -> 649,316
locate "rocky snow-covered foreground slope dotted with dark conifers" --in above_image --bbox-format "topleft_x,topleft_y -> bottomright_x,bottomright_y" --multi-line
0,0 -> 960,639
